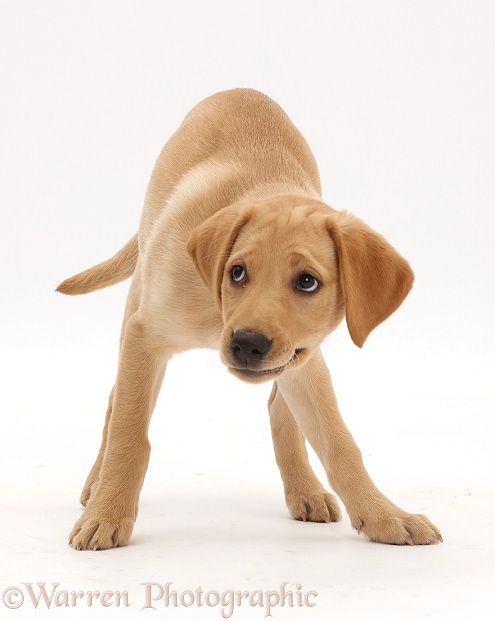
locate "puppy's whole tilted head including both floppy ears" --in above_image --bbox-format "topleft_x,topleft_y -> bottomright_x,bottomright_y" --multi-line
188,194 -> 413,382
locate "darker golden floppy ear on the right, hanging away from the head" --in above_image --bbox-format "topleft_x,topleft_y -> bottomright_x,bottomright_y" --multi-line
327,212 -> 414,347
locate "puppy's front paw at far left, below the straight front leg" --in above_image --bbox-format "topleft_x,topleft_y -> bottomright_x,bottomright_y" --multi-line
69,509 -> 134,550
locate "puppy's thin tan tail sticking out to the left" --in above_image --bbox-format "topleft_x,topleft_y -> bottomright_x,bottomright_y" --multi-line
55,233 -> 139,295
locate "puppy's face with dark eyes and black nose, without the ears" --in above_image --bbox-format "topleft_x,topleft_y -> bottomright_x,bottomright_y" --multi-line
220,200 -> 344,382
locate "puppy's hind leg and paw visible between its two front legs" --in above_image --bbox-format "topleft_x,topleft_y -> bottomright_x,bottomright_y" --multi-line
268,382 -> 341,522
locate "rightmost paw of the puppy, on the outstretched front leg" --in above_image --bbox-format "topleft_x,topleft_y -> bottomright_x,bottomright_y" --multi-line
351,508 -> 443,546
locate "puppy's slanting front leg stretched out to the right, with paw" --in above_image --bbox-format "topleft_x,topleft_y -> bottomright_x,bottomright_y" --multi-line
277,351 -> 442,545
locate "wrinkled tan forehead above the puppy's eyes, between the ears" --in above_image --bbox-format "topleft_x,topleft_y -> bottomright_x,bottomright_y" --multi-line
231,205 -> 336,269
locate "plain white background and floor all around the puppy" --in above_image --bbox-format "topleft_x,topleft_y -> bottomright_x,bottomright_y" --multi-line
0,0 -> 495,621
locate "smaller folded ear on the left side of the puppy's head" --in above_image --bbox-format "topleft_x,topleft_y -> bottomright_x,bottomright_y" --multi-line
187,205 -> 253,306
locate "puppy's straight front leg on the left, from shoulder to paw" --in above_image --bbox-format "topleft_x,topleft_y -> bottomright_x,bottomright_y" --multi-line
69,315 -> 166,550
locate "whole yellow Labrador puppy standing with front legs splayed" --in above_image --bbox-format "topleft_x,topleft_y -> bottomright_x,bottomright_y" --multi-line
58,89 -> 442,550
